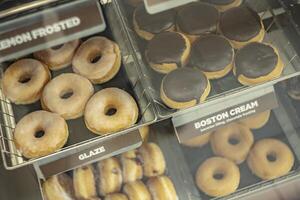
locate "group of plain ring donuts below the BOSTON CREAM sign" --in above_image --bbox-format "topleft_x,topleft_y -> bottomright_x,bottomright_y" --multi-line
184,111 -> 294,197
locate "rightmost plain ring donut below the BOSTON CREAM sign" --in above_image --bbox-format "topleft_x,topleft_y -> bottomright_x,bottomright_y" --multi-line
247,138 -> 295,180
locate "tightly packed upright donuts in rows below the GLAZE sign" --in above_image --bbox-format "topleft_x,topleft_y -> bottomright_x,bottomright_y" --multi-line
43,143 -> 178,200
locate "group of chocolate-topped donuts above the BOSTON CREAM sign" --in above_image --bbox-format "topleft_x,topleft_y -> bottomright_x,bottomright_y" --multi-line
131,0 -> 284,109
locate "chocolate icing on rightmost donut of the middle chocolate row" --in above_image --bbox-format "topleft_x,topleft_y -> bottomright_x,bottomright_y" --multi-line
235,42 -> 278,78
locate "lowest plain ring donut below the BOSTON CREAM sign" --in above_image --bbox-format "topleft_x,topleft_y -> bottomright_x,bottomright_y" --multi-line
196,157 -> 240,197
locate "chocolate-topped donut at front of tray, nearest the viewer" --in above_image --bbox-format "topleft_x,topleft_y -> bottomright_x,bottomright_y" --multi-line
160,67 -> 210,109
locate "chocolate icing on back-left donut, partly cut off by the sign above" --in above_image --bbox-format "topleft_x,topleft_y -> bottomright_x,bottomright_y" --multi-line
135,4 -> 176,34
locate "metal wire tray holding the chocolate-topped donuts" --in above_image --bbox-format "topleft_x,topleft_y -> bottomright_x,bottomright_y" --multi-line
113,0 -> 300,119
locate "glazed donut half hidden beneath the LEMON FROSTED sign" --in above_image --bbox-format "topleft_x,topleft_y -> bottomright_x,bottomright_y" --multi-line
33,40 -> 80,70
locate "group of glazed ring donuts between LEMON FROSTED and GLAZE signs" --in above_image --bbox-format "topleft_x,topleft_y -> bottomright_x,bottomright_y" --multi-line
2,36 -> 139,159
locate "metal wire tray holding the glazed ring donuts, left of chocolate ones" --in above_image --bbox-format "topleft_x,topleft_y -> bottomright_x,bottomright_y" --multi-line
0,3 -> 156,169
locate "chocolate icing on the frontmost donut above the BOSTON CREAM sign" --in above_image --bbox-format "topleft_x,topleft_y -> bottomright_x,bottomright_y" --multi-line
162,67 -> 208,103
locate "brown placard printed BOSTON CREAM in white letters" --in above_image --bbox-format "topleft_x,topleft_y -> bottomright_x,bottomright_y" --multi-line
174,92 -> 278,142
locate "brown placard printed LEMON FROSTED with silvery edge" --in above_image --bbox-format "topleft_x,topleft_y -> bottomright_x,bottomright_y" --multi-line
0,0 -> 106,62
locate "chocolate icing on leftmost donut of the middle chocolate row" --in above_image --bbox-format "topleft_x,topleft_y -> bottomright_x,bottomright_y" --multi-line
146,32 -> 187,66
